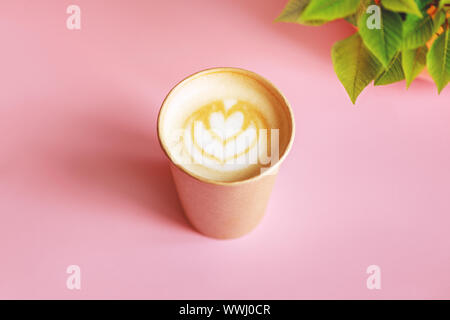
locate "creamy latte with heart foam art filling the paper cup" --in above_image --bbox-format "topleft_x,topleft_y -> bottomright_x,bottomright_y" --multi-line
158,69 -> 293,182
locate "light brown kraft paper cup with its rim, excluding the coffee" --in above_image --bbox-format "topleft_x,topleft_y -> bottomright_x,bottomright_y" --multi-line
158,68 -> 295,239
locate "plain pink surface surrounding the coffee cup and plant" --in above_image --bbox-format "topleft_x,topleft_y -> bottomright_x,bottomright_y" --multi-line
0,0 -> 450,299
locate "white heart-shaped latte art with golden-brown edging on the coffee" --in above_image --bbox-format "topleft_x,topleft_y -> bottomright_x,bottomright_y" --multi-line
183,99 -> 268,170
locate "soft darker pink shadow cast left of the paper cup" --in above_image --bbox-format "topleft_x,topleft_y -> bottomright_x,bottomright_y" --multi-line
47,104 -> 193,231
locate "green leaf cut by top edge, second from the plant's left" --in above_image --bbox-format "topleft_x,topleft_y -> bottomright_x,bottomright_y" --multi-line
301,0 -> 360,21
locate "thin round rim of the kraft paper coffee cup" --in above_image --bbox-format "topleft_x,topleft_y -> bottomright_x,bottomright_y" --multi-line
157,67 -> 295,186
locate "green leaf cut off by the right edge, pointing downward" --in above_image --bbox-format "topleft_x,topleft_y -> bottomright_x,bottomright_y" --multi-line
427,29 -> 450,93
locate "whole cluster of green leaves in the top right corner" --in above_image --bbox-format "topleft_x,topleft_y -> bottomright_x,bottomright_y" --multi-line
276,0 -> 450,103
